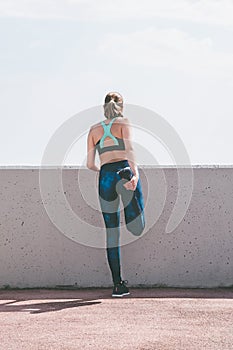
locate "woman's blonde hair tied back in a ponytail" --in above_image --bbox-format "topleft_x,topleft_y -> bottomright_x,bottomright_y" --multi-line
103,92 -> 123,119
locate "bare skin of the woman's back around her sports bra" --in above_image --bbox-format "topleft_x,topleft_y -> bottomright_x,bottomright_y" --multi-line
93,117 -> 127,166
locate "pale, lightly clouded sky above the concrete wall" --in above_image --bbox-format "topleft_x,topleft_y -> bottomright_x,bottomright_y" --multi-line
0,0 -> 233,166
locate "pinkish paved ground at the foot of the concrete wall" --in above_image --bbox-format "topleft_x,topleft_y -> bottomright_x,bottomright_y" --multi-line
0,288 -> 233,350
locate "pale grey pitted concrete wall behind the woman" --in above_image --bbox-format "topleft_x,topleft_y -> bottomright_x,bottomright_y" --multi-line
0,166 -> 233,288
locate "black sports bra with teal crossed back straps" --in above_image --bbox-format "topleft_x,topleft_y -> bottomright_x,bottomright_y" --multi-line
95,117 -> 125,154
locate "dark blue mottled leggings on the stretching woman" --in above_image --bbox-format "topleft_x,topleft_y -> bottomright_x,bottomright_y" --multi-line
98,160 -> 145,284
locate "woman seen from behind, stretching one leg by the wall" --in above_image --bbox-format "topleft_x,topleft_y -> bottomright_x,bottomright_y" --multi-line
86,92 -> 145,297
